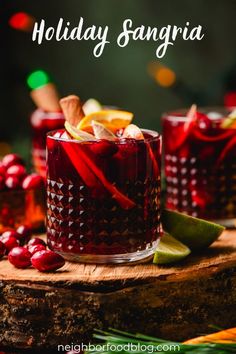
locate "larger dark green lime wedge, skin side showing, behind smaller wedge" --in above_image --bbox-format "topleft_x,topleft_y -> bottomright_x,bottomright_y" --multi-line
162,209 -> 225,251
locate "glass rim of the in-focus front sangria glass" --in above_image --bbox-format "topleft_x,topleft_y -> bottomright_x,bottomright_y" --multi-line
47,128 -> 162,145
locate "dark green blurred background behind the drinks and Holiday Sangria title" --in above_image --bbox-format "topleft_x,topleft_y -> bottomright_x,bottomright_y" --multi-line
0,0 -> 236,162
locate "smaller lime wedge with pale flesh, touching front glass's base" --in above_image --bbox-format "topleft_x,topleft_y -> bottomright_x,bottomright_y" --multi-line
153,234 -> 191,264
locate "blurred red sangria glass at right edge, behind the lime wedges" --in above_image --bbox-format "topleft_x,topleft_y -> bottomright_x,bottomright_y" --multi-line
163,106 -> 236,227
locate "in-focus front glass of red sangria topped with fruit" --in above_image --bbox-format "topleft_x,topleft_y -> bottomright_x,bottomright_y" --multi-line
47,94 -> 161,263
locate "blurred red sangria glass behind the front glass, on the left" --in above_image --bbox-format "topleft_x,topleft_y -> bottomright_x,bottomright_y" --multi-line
31,109 -> 65,178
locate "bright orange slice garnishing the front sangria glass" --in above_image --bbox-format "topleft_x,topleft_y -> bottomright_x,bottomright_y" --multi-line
77,110 -> 133,133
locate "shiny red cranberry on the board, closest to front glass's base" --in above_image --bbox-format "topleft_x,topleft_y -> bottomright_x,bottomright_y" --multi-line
31,250 -> 65,272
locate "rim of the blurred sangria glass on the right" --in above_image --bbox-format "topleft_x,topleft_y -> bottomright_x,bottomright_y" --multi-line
161,106 -> 230,121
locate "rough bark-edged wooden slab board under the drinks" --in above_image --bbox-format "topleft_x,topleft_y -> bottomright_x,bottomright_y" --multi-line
0,231 -> 236,349
